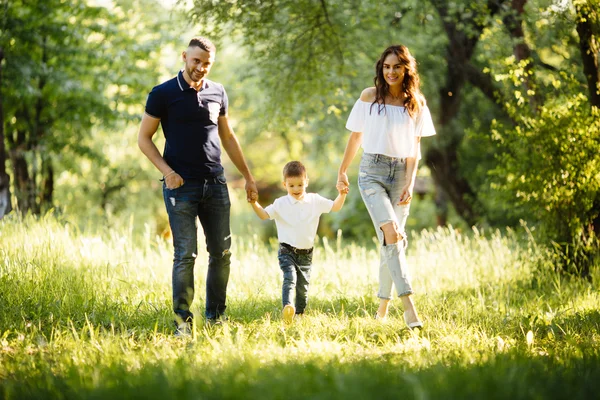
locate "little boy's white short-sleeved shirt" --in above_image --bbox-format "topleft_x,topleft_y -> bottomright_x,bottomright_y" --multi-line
265,193 -> 333,249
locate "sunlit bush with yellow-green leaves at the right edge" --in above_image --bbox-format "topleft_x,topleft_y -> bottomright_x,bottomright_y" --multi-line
492,2 -> 600,276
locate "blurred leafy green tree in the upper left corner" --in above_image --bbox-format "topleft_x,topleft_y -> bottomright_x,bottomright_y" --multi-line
0,0 -> 171,214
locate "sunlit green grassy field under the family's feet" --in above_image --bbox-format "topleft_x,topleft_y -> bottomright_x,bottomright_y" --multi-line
0,214 -> 600,399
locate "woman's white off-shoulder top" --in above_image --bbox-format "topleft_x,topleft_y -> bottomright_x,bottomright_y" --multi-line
346,99 -> 435,158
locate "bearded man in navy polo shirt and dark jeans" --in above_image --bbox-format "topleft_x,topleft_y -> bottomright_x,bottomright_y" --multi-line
138,37 -> 258,334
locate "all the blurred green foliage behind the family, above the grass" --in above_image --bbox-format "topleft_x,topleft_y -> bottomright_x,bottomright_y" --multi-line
0,0 -> 598,256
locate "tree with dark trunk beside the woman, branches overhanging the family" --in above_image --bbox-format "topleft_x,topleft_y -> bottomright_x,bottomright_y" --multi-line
192,0 -> 520,224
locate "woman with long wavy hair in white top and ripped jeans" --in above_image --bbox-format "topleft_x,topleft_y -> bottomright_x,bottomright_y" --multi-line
338,45 -> 435,329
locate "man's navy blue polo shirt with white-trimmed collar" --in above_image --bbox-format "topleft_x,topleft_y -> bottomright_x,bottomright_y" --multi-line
146,71 -> 228,179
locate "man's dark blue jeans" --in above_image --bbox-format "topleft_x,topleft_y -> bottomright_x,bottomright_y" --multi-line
163,175 -> 231,322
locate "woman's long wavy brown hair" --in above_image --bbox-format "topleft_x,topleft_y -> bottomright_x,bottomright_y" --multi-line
371,45 -> 425,118
